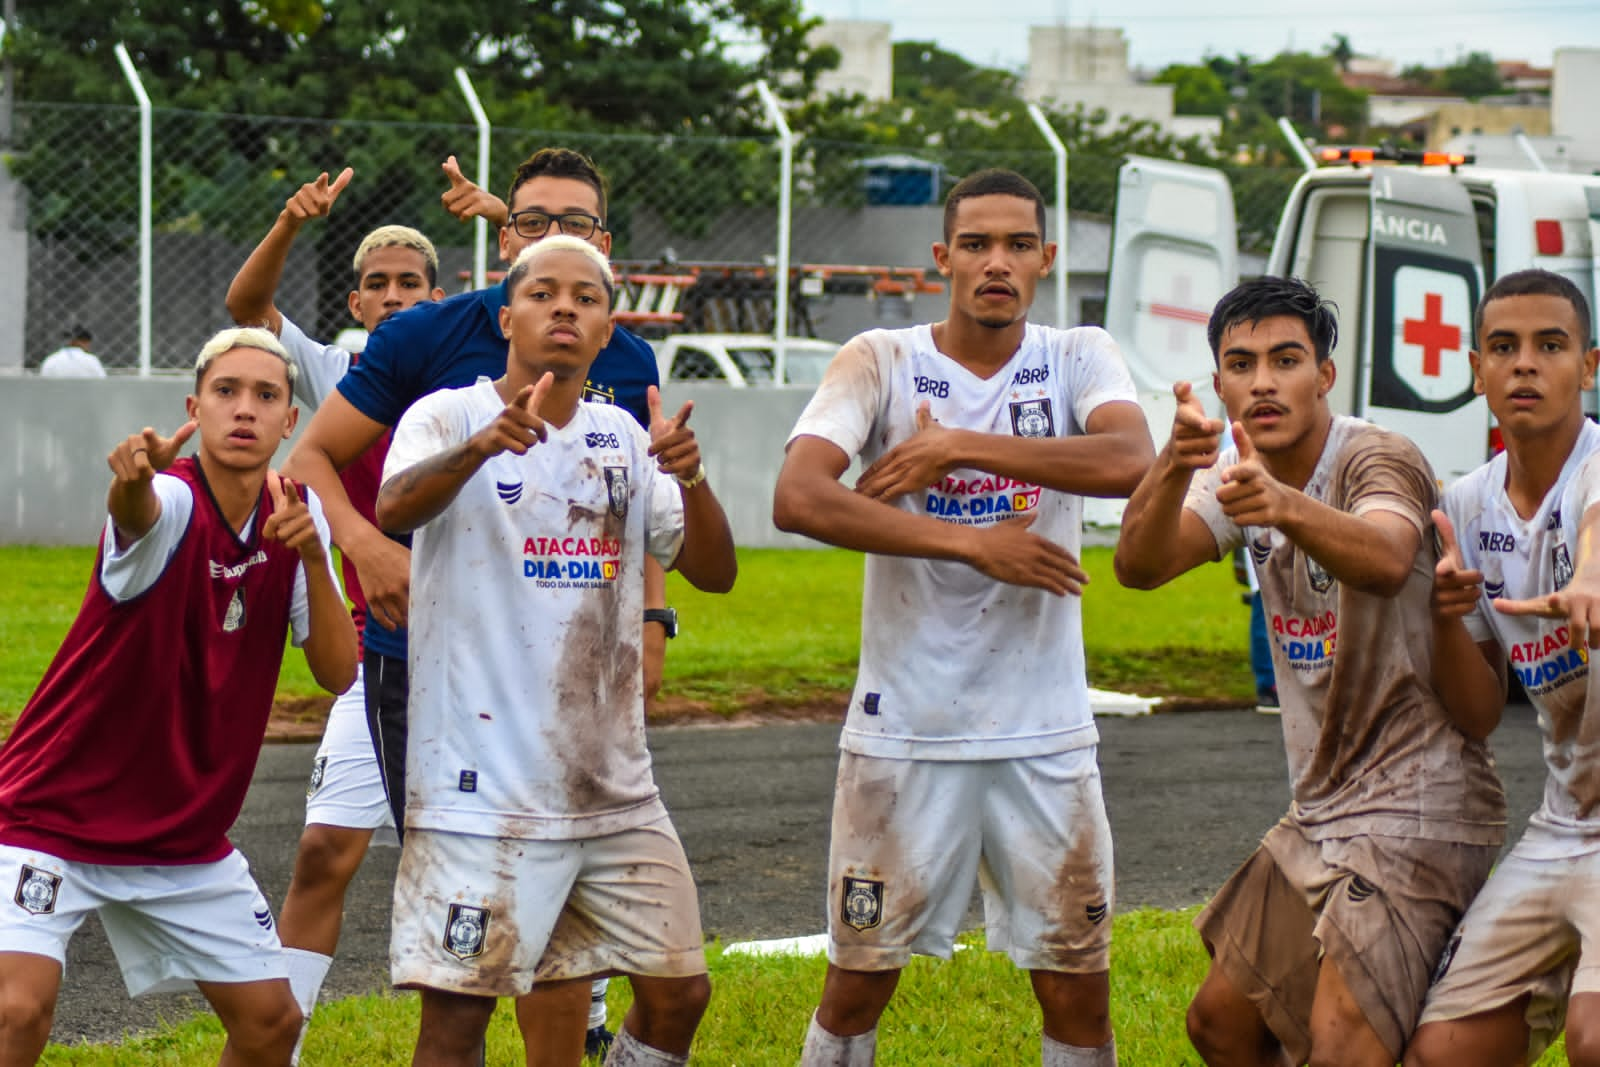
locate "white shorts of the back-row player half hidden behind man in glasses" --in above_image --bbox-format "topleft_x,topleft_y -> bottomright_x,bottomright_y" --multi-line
306,667 -> 400,846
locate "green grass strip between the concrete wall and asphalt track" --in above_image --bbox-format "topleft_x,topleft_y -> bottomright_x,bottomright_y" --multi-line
0,547 -> 1254,736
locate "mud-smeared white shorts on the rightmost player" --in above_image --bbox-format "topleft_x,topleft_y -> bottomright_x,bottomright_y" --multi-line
1422,825 -> 1600,1064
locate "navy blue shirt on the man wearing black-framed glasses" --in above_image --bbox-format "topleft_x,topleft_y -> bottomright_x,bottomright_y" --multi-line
339,282 -> 661,659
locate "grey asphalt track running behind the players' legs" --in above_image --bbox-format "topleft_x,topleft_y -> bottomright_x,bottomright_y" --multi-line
53,707 -> 1544,1041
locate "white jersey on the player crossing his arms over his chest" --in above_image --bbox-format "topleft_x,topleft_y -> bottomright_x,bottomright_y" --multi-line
790,325 -> 1138,760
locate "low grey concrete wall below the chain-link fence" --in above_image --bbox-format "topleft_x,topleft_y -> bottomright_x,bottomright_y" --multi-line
0,376 -> 811,547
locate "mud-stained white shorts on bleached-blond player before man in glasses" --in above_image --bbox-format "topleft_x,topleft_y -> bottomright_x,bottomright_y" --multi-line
389,816 -> 706,997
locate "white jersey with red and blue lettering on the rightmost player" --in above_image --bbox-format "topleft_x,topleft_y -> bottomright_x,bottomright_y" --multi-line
1443,419 -> 1600,849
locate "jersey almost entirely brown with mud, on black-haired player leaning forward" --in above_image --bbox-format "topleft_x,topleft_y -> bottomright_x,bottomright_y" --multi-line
1184,416 -> 1506,845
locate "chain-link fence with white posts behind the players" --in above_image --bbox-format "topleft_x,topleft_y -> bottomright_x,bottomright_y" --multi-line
0,104 -> 1293,370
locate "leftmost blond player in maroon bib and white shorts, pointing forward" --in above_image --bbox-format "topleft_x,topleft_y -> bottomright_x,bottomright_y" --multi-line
0,330 -> 355,1065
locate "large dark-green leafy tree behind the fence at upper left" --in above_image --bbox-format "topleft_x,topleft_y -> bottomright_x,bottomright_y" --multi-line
5,0 -> 838,330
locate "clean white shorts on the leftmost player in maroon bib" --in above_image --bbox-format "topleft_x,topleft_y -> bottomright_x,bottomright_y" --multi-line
0,845 -> 288,997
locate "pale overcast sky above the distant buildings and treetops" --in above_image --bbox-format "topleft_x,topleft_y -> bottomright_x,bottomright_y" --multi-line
803,0 -> 1600,69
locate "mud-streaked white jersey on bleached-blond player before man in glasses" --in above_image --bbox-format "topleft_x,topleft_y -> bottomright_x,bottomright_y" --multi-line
393,379 -> 683,840
